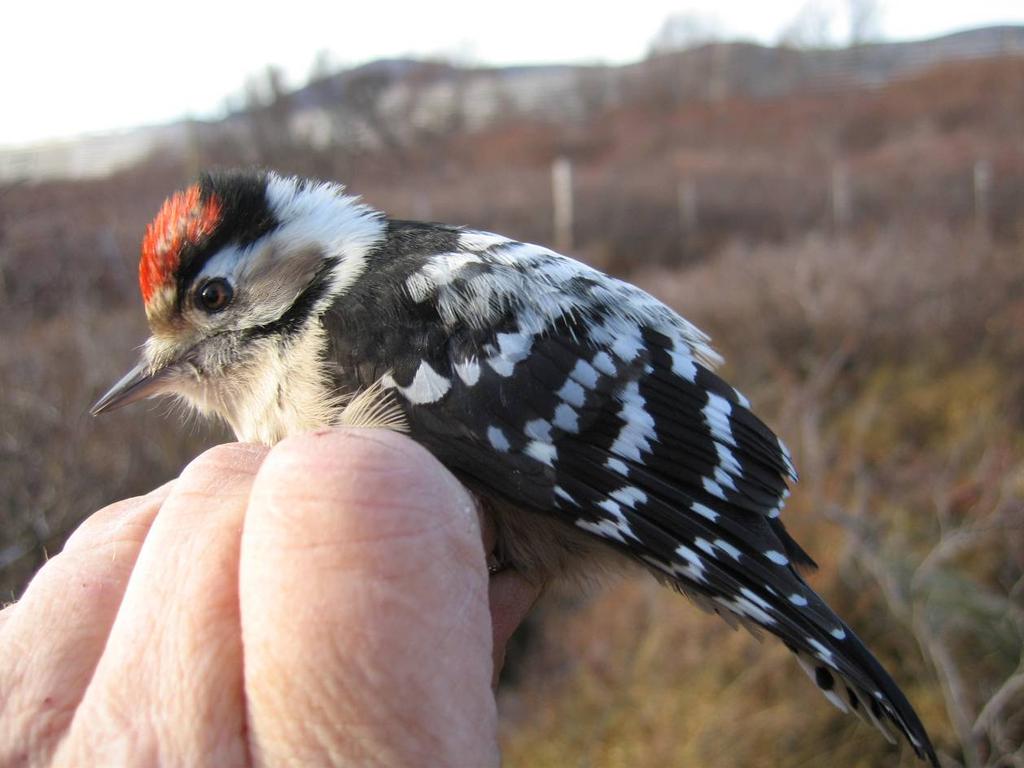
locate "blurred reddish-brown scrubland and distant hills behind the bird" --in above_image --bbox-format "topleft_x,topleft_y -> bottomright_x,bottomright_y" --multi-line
0,7 -> 1024,768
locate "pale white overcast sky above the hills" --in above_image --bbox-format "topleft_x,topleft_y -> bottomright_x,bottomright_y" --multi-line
0,0 -> 1024,145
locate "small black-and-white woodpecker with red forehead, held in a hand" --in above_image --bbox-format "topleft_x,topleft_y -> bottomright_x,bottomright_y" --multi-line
91,169 -> 938,766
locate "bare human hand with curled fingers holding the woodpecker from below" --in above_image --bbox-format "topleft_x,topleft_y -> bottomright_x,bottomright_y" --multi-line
0,430 -> 537,768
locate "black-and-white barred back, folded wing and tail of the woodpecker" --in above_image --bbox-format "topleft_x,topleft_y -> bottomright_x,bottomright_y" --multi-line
326,215 -> 937,765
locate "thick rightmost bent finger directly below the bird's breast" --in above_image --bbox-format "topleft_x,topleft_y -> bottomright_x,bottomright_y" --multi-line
240,430 -> 497,766
